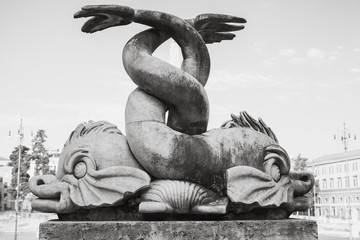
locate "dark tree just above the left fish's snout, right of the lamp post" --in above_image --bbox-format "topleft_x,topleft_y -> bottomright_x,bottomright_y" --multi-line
29,129 -> 50,175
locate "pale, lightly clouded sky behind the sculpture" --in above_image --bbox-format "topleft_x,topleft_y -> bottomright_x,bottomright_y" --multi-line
0,0 -> 360,159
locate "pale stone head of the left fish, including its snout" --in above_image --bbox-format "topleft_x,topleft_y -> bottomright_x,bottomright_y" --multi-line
29,121 -> 150,213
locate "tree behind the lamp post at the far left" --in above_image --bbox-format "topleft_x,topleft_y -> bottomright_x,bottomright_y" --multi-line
9,146 -> 30,199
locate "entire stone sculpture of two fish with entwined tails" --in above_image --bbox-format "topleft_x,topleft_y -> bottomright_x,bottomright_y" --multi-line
29,5 -> 314,219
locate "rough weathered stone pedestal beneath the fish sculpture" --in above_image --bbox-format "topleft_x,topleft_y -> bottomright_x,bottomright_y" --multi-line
39,219 -> 318,240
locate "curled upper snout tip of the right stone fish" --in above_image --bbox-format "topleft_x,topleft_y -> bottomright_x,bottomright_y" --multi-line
289,171 -> 315,197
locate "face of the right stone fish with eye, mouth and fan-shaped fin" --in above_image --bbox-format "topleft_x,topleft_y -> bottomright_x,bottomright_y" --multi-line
226,145 -> 315,213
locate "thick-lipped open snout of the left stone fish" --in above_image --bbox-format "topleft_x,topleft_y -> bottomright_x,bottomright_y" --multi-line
29,175 -> 76,213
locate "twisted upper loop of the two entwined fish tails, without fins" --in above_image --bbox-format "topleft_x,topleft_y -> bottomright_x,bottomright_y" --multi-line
123,10 -> 210,135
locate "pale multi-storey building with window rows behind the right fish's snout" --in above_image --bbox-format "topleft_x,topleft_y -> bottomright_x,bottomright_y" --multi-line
307,150 -> 360,219
